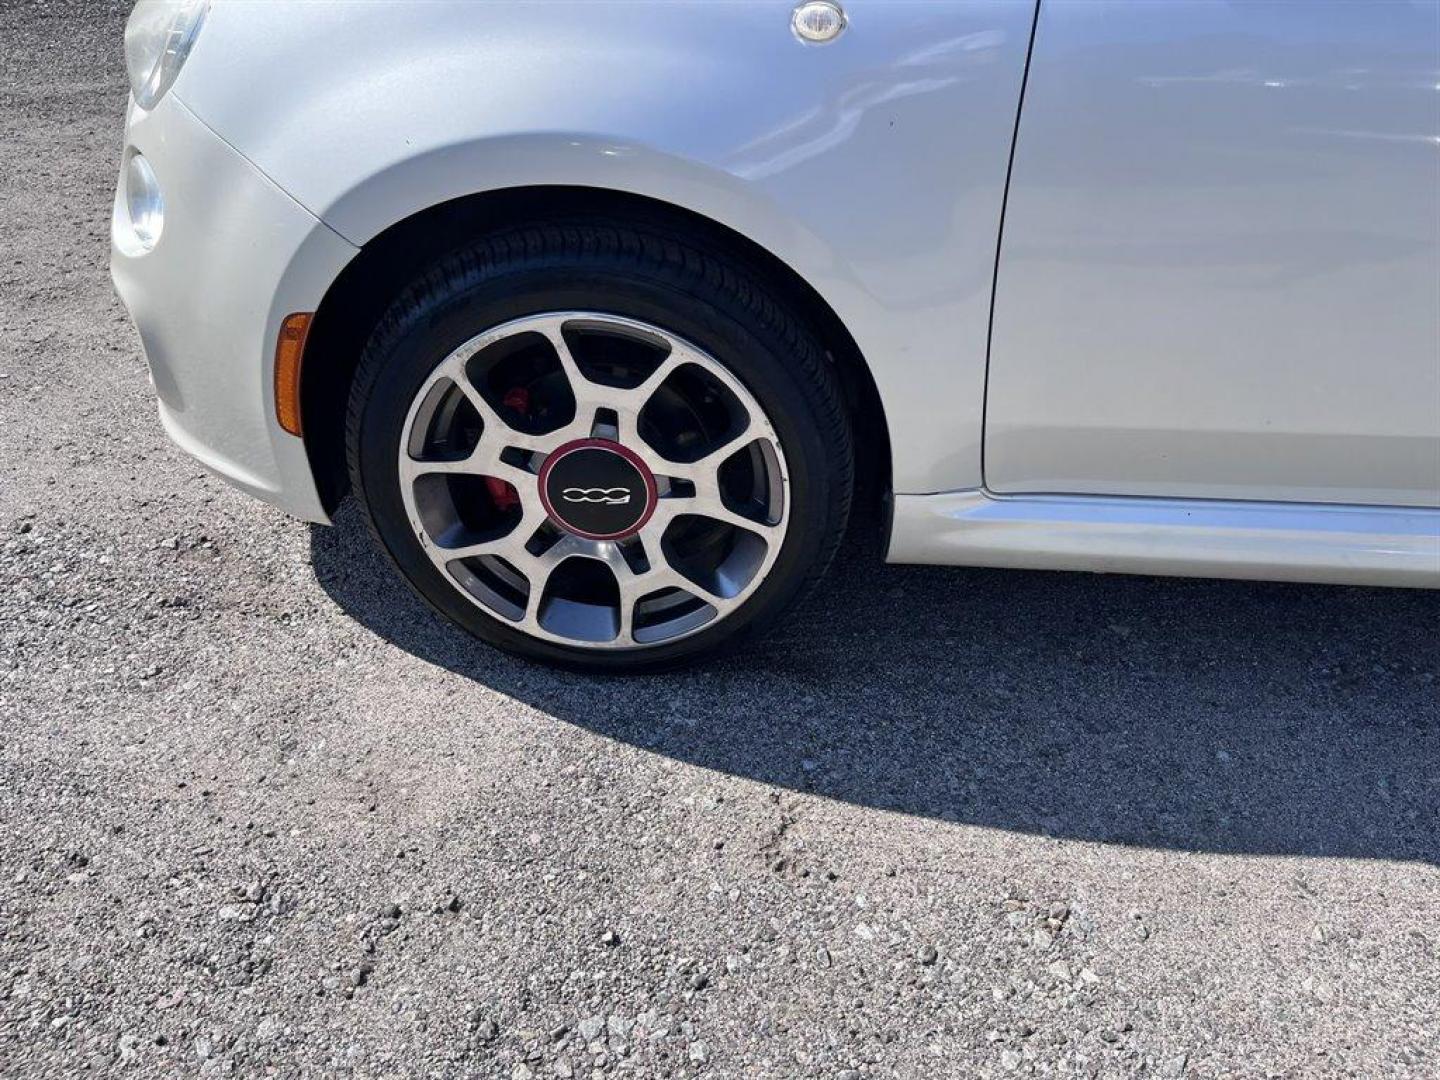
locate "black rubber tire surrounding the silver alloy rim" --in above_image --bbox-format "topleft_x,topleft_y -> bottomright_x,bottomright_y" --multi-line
346,220 -> 854,672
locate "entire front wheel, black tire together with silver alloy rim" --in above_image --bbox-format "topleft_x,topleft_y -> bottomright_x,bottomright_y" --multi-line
347,223 -> 852,671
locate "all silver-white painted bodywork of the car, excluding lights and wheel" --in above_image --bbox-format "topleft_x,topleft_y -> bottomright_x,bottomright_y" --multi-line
114,0 -> 1440,585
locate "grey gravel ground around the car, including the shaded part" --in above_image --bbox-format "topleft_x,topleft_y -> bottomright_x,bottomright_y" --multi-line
0,0 -> 1440,1079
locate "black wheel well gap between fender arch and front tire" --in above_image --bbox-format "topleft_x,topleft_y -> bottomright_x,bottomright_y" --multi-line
301,187 -> 890,521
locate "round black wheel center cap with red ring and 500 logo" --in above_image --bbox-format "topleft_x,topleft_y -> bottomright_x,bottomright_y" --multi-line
540,439 -> 657,540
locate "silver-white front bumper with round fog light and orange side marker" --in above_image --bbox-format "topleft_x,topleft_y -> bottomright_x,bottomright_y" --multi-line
111,94 -> 357,521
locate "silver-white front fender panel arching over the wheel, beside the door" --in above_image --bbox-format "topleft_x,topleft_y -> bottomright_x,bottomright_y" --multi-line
176,0 -> 1035,491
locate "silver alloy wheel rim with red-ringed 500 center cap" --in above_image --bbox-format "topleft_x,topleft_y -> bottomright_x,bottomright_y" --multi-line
399,311 -> 788,649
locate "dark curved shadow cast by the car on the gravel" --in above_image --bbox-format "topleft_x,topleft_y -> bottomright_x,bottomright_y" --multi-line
311,505 -> 1440,864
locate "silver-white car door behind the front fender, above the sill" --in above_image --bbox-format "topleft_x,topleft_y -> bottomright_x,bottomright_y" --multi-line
984,0 -> 1440,505
